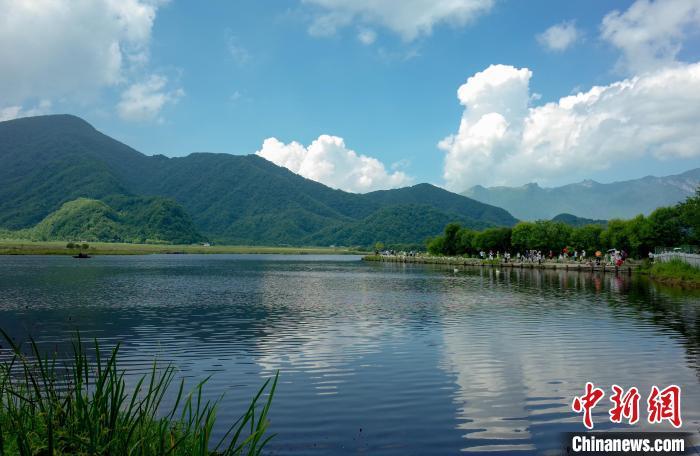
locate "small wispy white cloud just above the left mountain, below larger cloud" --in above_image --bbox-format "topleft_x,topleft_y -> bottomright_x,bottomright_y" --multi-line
117,75 -> 185,121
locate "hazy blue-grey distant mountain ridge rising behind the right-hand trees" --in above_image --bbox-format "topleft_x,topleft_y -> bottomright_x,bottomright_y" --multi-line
463,168 -> 700,220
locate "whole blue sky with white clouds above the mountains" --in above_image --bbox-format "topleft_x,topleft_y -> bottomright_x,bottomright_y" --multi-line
0,0 -> 700,191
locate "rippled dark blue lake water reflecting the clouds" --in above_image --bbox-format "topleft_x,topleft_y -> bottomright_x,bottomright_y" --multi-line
0,255 -> 700,455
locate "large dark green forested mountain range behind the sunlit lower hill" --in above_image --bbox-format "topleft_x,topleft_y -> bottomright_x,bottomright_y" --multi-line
0,115 -> 516,245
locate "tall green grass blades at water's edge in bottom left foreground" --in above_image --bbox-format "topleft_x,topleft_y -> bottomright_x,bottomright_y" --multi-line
0,331 -> 277,456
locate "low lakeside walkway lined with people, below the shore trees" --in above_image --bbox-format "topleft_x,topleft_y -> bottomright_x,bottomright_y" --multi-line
362,255 -> 639,274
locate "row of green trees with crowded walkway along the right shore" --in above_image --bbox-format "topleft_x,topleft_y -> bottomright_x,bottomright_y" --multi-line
364,189 -> 700,288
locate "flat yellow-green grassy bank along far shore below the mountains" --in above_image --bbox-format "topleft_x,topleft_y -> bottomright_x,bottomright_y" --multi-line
0,239 -> 363,255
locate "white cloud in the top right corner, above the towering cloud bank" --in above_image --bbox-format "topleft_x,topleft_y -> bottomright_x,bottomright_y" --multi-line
601,0 -> 700,74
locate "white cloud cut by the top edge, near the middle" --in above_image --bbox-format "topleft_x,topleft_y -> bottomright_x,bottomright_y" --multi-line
303,0 -> 495,41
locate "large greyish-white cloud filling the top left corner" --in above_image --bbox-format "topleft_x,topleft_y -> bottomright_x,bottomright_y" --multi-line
0,0 -> 160,103
